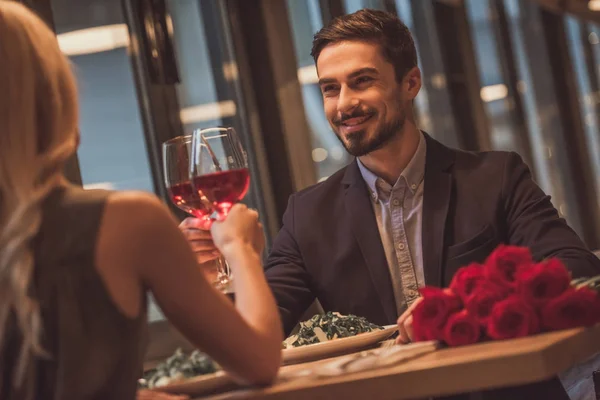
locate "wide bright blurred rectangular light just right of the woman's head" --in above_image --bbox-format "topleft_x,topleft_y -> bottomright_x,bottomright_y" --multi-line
56,24 -> 129,56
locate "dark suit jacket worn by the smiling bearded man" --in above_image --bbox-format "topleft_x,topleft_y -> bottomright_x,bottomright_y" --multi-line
266,135 -> 600,333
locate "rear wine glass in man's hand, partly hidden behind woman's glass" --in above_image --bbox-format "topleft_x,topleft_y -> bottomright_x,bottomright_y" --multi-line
163,135 -> 229,290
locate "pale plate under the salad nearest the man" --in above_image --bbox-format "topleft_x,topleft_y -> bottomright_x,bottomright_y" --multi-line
282,325 -> 398,364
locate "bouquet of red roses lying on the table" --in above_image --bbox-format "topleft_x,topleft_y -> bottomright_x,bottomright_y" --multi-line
412,245 -> 600,346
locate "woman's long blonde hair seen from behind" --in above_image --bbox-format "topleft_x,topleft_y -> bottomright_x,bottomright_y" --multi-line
0,0 -> 78,385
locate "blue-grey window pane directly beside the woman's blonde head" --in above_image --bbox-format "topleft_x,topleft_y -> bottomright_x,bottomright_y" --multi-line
53,0 -> 153,191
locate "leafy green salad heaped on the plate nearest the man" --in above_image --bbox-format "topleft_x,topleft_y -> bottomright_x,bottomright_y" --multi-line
283,311 -> 383,349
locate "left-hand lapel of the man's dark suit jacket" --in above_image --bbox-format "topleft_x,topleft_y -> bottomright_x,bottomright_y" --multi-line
343,161 -> 398,321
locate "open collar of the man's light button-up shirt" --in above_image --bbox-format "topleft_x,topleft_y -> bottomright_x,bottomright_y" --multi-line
356,133 -> 427,201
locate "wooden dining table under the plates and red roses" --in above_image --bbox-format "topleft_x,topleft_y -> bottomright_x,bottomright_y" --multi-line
197,325 -> 600,400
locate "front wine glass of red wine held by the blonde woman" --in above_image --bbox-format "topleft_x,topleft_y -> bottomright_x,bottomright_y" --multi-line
190,128 -> 250,287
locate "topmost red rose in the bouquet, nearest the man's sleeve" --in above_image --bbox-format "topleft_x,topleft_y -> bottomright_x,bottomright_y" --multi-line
485,245 -> 533,288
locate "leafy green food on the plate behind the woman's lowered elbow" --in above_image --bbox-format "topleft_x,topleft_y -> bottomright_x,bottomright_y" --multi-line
138,349 -> 221,389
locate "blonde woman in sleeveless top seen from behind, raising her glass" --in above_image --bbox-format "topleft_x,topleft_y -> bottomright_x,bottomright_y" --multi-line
0,0 -> 282,400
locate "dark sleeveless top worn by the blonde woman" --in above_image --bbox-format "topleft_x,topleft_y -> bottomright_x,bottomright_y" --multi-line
0,187 -> 147,400
